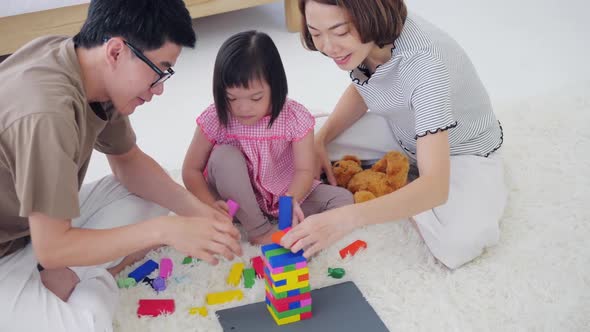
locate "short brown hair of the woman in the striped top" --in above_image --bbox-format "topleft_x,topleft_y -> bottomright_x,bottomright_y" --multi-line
299,0 -> 408,51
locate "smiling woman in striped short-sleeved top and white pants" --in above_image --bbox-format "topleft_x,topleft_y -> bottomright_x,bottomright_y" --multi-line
282,0 -> 507,269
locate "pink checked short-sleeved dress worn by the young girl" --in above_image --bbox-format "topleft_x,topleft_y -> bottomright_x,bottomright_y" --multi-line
197,99 -> 320,217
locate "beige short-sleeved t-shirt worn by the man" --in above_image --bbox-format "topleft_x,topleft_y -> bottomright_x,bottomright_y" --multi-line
0,36 -> 135,257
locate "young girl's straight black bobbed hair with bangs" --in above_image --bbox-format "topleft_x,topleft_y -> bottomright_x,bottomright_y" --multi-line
213,30 -> 288,127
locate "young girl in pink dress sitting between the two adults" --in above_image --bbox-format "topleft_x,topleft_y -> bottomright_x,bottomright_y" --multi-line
183,31 -> 353,244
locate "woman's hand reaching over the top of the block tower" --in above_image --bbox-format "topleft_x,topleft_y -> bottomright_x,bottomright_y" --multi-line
281,209 -> 356,258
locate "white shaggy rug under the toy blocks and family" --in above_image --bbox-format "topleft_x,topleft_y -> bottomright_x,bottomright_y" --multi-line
115,85 -> 590,332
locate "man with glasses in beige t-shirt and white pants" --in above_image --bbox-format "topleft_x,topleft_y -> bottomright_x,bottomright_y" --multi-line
0,0 -> 241,331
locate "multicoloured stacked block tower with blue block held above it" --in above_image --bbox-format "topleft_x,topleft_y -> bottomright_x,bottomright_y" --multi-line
262,196 -> 312,325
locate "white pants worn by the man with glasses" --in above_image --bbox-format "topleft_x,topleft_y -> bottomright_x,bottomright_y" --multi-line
0,176 -> 169,332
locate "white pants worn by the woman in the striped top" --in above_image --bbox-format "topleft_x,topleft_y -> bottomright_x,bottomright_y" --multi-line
316,112 -> 508,269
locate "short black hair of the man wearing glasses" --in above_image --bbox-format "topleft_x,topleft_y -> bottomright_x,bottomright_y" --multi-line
74,0 -> 196,51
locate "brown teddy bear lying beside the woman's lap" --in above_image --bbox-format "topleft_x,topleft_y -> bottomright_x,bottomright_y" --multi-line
332,151 -> 410,203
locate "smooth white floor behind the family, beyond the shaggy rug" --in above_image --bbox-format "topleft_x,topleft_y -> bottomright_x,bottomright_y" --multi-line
86,0 -> 590,182
